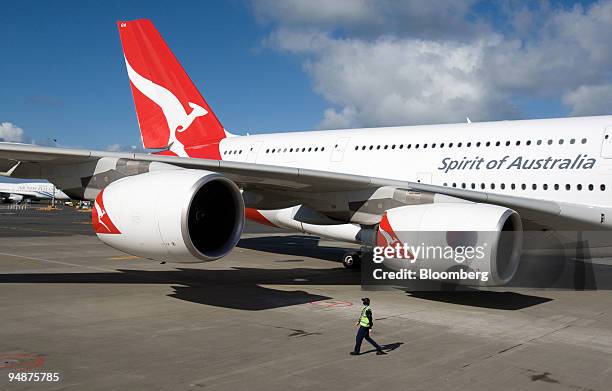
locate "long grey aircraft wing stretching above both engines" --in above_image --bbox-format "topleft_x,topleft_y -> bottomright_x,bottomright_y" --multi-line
0,143 -> 562,216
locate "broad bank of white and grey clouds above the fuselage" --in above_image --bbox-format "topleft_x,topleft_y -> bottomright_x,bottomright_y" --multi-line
254,0 -> 612,128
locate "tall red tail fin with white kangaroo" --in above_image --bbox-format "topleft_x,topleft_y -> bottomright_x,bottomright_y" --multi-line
117,19 -> 225,159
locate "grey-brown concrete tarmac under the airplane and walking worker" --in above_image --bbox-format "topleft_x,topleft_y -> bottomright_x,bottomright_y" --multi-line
0,208 -> 612,391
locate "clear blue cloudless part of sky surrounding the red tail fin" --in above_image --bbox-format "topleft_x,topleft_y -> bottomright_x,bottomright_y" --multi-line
0,1 -> 324,149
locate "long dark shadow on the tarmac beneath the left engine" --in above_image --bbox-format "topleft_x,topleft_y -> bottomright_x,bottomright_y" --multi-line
0,268 -> 360,311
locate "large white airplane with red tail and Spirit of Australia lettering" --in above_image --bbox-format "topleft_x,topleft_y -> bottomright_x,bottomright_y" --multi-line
0,19 -> 612,285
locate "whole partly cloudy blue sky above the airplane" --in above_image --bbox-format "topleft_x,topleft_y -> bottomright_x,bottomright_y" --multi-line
0,0 -> 612,158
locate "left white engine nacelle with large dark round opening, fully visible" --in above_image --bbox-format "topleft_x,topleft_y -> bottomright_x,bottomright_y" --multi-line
92,169 -> 244,262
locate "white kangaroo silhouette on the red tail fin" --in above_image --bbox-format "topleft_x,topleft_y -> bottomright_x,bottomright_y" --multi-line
124,57 -> 208,156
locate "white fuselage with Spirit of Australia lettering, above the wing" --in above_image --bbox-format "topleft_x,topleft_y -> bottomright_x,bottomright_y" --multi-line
220,116 -> 612,207
